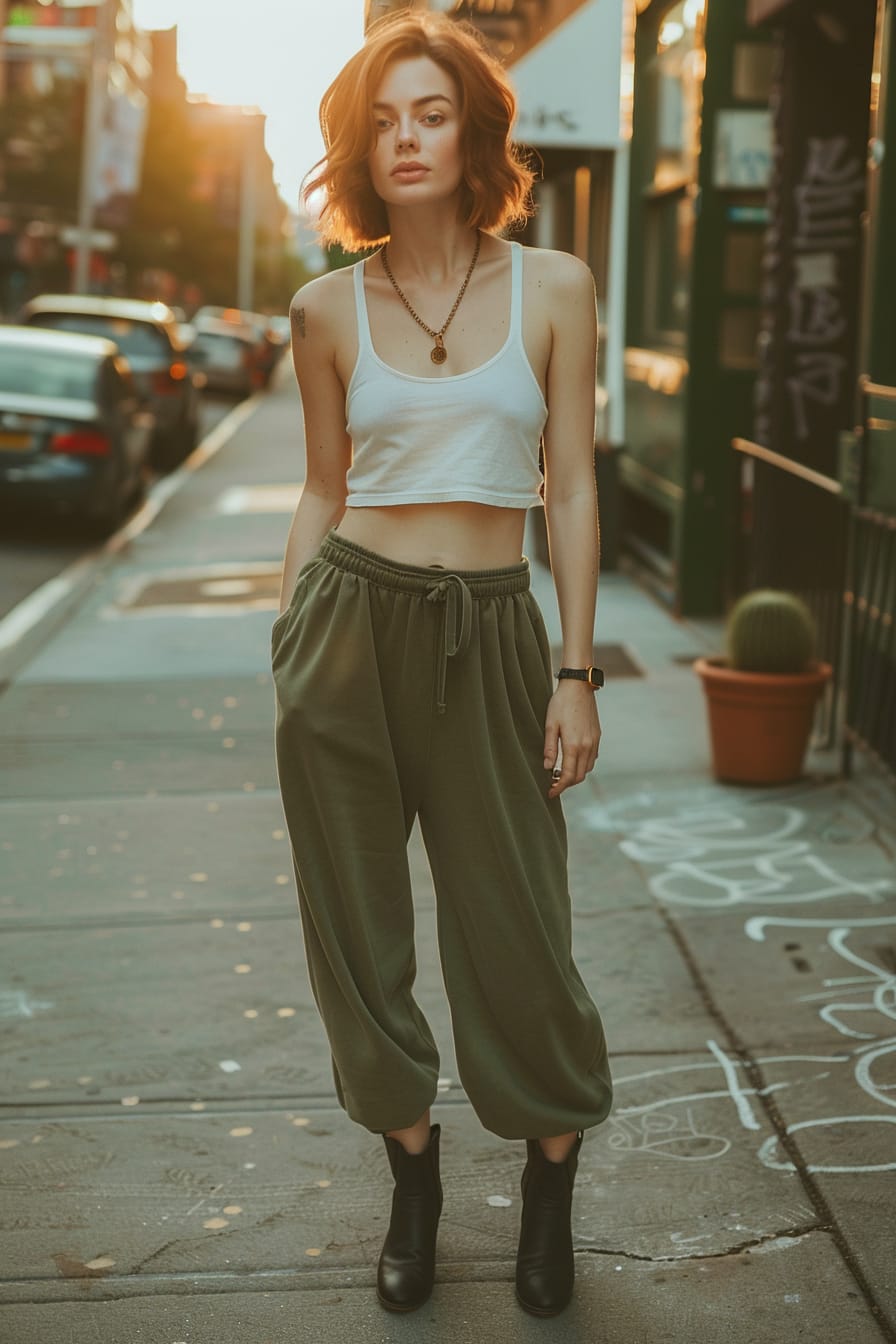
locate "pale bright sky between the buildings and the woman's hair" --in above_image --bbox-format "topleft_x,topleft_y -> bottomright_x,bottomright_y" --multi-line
133,0 -> 364,207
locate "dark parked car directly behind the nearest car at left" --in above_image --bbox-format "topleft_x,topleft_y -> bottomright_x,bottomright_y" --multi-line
20,294 -> 201,472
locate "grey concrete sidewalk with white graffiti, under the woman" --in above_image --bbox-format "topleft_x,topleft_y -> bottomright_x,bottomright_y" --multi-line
0,376 -> 896,1344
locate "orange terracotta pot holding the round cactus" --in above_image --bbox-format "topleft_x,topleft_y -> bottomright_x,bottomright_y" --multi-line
695,659 -> 832,784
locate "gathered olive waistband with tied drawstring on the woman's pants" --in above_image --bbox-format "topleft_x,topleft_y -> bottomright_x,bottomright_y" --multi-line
317,531 -> 529,714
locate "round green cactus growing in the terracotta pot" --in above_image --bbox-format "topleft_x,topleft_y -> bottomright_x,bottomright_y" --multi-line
727,589 -> 815,675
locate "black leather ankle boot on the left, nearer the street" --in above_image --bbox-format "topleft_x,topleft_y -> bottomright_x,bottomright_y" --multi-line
376,1125 -> 442,1312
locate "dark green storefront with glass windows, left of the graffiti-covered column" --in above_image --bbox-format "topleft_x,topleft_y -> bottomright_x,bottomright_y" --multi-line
619,0 -> 774,616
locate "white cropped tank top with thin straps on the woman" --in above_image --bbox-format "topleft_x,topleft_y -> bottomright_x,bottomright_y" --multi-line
345,243 -> 548,508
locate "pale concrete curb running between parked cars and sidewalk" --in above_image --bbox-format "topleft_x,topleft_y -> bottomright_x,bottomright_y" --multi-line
0,392 -> 265,682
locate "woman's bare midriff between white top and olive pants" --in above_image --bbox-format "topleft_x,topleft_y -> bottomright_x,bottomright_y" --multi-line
336,501 -> 525,570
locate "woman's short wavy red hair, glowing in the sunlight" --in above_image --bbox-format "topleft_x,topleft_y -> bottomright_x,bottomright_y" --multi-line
302,12 -> 535,251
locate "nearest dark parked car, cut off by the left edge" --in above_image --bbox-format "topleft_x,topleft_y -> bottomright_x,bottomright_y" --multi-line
0,327 -> 154,532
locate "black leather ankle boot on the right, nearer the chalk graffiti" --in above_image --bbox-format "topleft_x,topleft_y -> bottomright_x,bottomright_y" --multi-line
516,1133 -> 584,1316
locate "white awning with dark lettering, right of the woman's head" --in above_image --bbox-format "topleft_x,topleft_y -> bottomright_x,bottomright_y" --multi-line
508,0 -> 630,149
